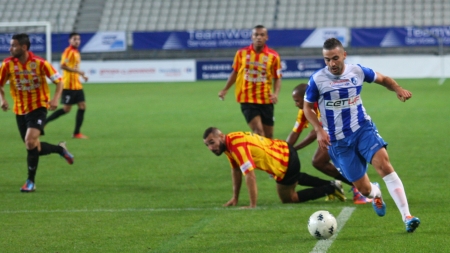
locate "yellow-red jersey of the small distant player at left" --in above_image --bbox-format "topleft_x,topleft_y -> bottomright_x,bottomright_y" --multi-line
61,46 -> 83,90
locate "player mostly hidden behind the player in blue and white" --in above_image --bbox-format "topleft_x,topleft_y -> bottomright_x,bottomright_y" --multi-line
286,83 -> 371,204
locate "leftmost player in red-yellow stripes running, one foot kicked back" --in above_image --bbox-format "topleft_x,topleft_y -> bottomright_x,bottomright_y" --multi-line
0,33 -> 73,192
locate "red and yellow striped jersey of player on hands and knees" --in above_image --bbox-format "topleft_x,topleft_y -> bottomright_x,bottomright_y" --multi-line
225,132 -> 289,181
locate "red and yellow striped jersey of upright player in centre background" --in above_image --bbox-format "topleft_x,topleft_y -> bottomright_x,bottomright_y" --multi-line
233,45 -> 281,104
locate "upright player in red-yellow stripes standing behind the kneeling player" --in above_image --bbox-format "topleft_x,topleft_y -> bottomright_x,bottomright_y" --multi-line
219,25 -> 281,138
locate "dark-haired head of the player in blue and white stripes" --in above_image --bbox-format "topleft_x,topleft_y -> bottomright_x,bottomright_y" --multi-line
322,38 -> 347,75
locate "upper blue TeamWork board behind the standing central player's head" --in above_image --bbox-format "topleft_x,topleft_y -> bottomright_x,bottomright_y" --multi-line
133,27 -> 349,50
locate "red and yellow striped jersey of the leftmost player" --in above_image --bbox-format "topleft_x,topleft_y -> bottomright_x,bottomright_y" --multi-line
0,52 -> 61,115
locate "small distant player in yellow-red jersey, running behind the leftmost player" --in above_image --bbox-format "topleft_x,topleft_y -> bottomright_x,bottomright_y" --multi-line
46,32 -> 88,139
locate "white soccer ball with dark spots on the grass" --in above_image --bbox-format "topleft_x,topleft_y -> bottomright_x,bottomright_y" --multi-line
308,210 -> 337,240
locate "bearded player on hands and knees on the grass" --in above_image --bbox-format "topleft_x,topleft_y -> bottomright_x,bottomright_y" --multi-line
203,127 -> 345,208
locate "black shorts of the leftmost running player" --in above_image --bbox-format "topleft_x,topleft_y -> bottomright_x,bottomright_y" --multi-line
16,107 -> 47,141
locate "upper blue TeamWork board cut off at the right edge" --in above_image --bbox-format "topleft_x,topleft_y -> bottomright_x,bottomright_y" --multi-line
351,26 -> 450,47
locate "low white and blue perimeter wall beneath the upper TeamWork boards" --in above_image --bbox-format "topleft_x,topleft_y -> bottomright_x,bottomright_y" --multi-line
64,55 -> 450,83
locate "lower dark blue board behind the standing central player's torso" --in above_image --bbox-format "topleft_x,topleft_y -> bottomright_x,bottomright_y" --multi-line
196,59 -> 325,80
